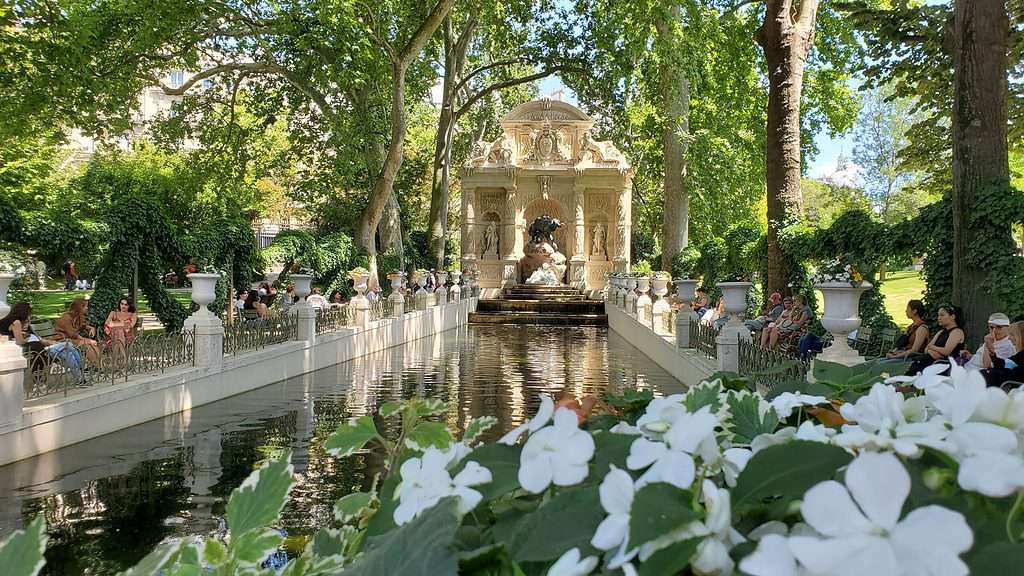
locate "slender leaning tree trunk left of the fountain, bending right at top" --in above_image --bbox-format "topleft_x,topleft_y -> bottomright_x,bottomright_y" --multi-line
354,0 -> 456,287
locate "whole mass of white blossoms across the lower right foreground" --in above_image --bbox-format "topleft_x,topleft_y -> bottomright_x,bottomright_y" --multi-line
394,366 -> 1024,576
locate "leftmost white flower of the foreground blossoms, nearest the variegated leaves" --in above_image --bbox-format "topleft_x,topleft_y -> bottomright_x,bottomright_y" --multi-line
394,448 -> 492,526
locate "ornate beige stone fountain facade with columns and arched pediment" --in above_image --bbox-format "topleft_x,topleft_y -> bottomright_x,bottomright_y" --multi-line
461,99 -> 633,295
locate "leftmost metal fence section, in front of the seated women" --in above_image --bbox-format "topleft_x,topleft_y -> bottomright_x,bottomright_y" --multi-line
25,330 -> 196,398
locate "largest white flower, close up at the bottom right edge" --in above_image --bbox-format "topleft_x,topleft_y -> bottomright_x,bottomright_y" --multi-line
786,452 -> 974,576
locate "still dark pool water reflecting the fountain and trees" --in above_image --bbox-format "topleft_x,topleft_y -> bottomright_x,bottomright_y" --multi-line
0,325 -> 682,575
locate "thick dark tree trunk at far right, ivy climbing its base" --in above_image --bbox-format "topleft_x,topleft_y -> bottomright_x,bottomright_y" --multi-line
952,0 -> 1010,342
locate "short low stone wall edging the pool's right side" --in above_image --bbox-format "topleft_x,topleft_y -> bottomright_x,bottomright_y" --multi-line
605,301 -> 718,386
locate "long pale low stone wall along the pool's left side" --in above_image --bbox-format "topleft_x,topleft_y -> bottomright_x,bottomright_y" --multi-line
0,298 -> 477,465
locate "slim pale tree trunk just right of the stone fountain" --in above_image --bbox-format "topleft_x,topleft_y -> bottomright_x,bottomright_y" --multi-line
655,4 -> 690,272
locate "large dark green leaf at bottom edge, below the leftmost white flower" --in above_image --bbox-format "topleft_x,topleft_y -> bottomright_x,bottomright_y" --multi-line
345,498 -> 459,576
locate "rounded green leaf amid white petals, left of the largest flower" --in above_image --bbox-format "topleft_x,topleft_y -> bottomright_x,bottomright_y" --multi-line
630,482 -> 700,548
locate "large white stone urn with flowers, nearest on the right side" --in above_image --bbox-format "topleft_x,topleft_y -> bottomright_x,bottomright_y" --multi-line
812,257 -> 871,365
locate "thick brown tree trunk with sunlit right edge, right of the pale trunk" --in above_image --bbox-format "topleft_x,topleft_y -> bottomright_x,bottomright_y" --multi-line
756,0 -> 818,293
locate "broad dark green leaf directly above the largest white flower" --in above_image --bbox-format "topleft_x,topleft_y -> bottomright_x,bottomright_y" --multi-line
732,440 -> 853,510
